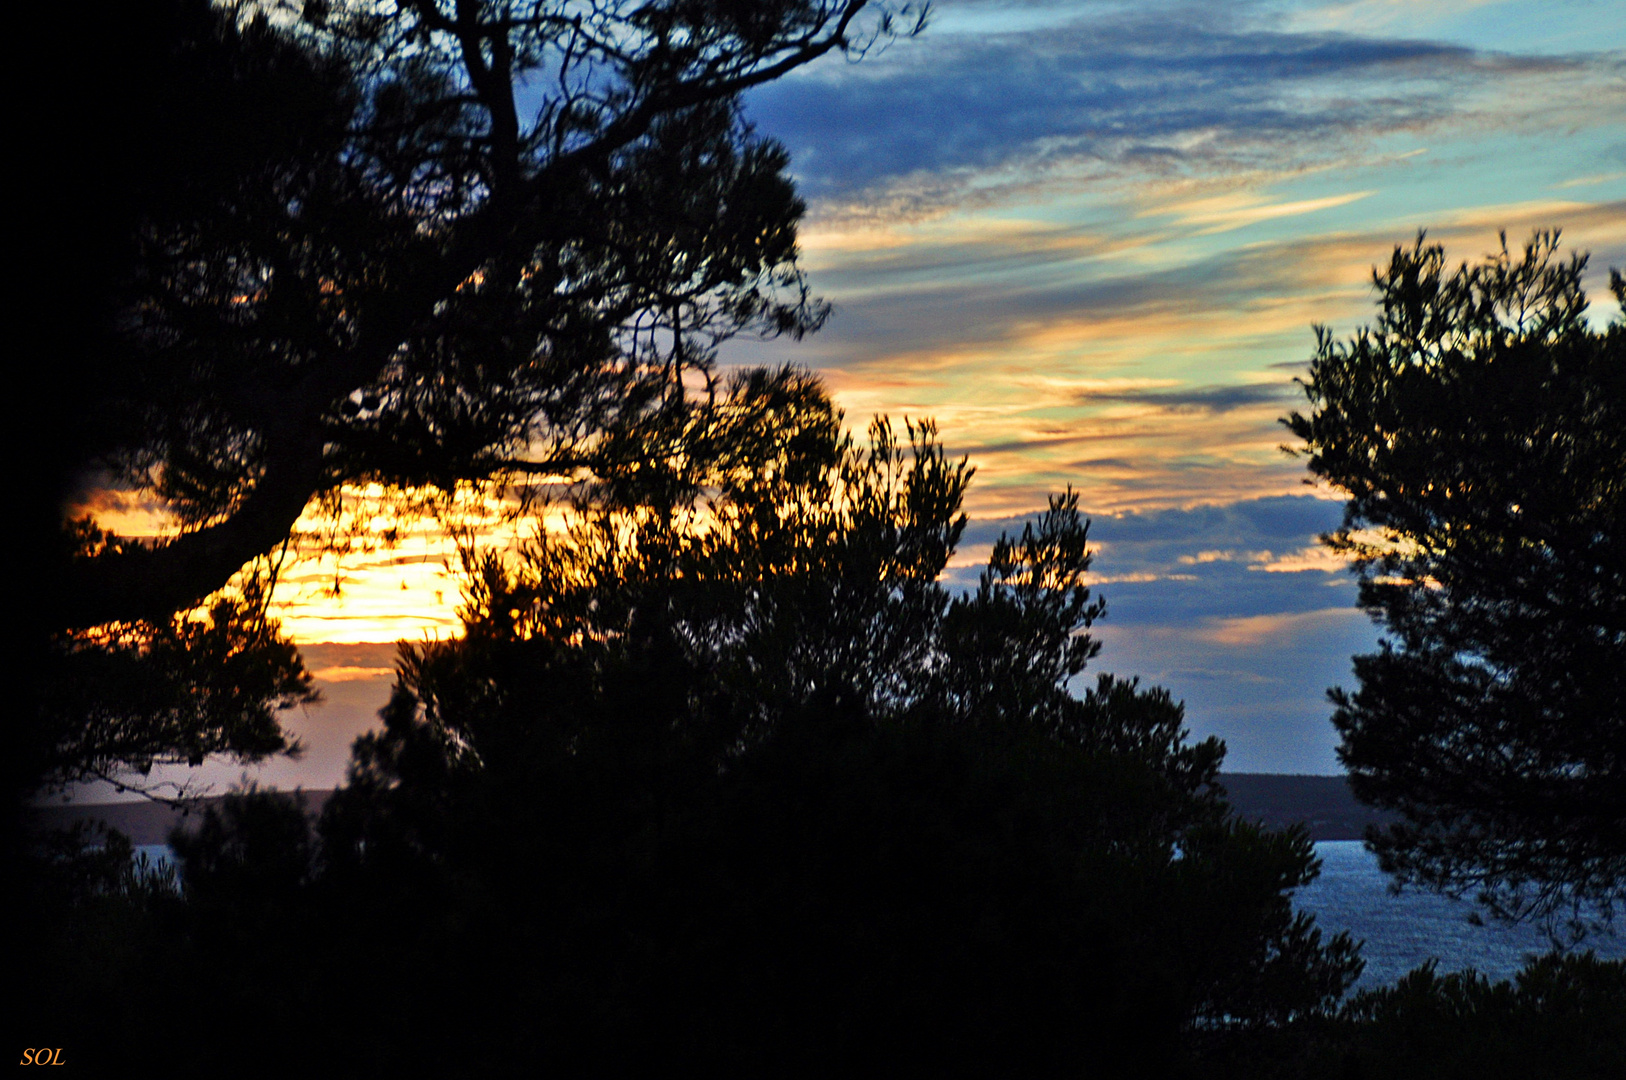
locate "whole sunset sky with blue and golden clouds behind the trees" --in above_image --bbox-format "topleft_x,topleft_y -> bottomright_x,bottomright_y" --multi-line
73,0 -> 1626,787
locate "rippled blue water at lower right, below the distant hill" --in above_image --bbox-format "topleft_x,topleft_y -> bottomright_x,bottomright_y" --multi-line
1294,839 -> 1626,989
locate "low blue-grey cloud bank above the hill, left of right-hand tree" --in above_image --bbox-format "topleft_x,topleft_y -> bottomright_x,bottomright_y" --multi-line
1001,496 -> 1377,773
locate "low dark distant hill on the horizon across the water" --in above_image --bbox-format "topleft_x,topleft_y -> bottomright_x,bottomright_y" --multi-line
34,773 -> 1395,844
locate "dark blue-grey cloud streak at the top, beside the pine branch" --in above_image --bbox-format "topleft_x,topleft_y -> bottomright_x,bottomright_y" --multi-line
751,8 -> 1468,194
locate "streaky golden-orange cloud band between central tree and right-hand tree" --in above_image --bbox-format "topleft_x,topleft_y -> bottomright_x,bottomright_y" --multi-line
725,198 -> 1626,520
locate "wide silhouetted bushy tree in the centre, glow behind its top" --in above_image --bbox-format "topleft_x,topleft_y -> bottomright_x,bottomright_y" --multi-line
63,371 -> 1359,1075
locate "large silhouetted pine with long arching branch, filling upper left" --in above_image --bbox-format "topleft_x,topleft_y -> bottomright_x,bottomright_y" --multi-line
31,0 -> 924,793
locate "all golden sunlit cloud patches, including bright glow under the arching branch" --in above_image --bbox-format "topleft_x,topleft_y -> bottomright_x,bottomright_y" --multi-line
81,188 -> 1626,644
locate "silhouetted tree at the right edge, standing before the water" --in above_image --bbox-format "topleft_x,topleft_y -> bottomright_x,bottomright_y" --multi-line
1285,233 -> 1626,930
